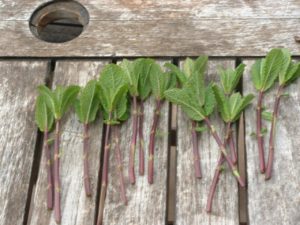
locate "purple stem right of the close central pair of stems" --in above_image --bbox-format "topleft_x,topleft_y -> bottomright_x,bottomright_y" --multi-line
148,99 -> 161,184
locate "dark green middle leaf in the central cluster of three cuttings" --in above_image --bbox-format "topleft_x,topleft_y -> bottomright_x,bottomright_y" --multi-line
135,59 -> 155,101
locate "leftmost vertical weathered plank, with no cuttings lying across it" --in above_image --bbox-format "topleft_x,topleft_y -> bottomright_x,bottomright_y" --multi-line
0,61 -> 48,225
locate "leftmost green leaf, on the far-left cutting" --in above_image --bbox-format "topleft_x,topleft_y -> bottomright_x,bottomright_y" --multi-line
35,95 -> 54,132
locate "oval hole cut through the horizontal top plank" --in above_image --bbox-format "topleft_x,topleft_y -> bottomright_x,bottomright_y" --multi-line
29,0 -> 89,43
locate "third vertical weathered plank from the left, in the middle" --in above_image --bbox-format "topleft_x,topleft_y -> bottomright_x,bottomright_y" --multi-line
103,60 -> 169,225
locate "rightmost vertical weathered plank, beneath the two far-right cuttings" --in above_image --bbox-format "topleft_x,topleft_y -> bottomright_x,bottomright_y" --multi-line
243,60 -> 300,225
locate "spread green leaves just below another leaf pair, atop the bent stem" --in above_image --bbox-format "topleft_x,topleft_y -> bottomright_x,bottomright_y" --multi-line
213,85 -> 254,123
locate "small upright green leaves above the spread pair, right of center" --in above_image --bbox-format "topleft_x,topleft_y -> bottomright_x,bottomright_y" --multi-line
218,64 -> 246,95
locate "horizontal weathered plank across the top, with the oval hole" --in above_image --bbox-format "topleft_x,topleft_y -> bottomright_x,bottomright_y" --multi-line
0,0 -> 300,57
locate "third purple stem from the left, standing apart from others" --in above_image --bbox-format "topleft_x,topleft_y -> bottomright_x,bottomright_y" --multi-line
83,124 -> 92,196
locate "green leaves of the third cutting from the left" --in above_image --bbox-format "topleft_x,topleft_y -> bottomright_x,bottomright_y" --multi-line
75,80 -> 100,124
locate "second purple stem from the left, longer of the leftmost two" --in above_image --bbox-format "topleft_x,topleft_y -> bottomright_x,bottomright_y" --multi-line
54,120 -> 61,223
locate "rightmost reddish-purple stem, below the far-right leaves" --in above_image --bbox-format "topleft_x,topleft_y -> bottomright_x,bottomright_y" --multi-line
265,85 -> 283,180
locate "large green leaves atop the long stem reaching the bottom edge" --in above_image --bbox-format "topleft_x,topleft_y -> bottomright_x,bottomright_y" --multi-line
98,64 -> 128,123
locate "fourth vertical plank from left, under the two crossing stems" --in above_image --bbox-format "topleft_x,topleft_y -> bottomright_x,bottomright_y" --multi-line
175,60 -> 239,225
